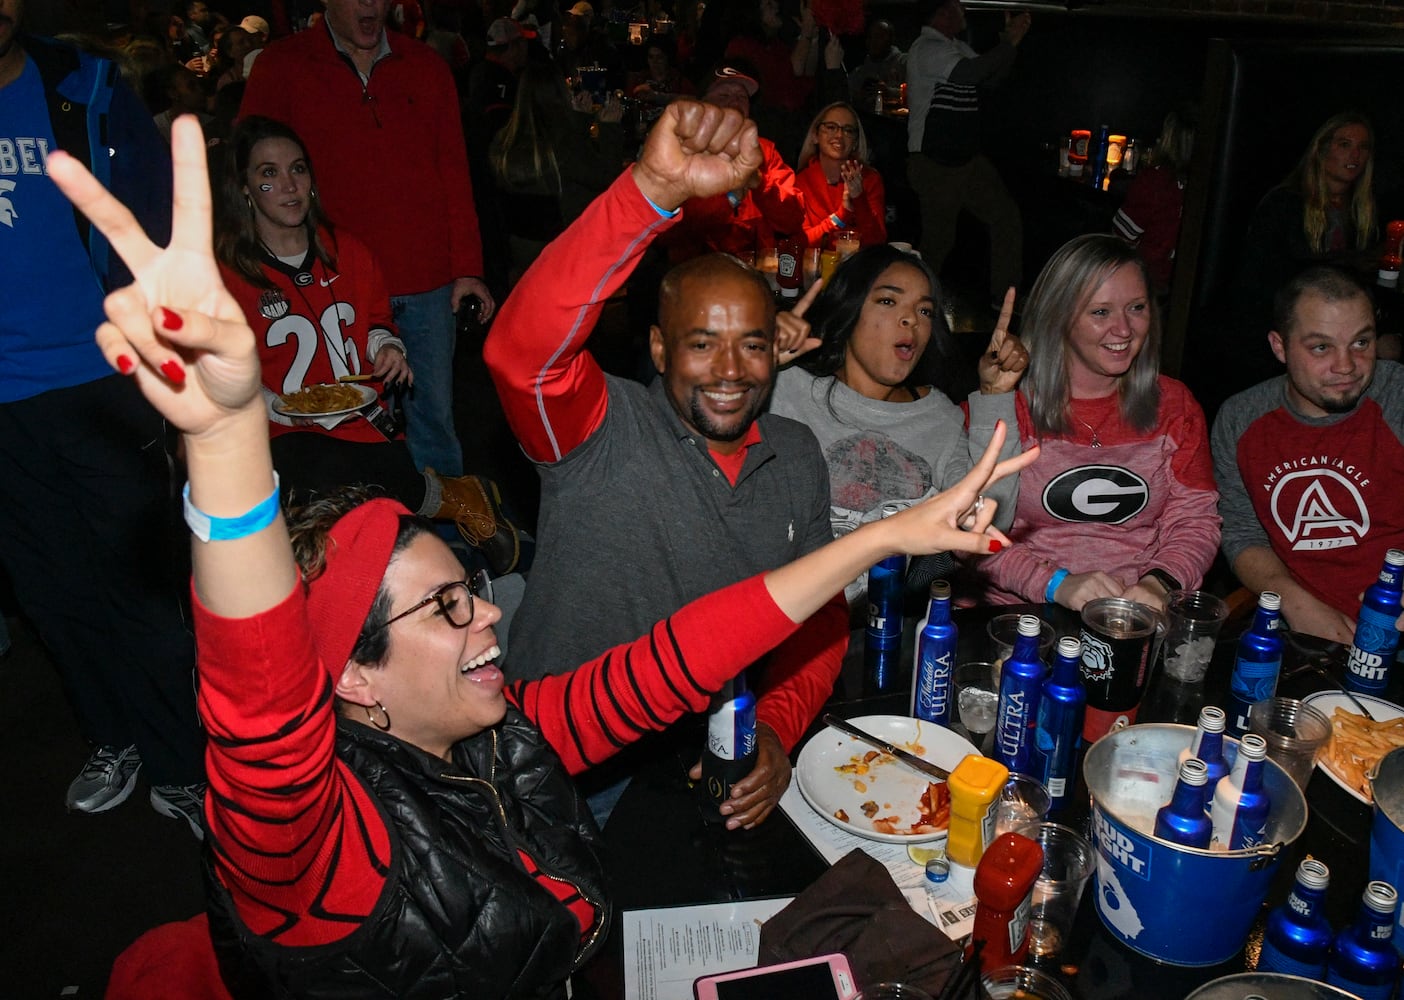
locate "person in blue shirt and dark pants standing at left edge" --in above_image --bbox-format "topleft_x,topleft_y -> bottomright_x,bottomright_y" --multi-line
0,0 -> 204,836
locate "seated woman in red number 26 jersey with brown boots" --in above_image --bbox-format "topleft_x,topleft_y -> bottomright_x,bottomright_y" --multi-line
215,117 -> 519,573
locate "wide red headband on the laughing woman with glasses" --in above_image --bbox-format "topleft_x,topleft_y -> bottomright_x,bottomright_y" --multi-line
307,499 -> 410,681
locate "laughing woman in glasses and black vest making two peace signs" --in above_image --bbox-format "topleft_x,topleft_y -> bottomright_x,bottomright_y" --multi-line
60,113 -> 1029,997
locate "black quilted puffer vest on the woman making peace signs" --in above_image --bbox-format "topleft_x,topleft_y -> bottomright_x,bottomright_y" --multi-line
206,708 -> 609,1000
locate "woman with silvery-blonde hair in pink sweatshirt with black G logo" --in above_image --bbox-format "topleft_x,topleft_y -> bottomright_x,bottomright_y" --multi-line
979,233 -> 1219,611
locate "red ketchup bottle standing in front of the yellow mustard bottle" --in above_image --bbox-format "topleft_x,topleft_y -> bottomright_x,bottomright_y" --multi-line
966,833 -> 1043,972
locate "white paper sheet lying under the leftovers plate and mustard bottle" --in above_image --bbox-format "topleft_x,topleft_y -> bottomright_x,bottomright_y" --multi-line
781,782 -> 974,941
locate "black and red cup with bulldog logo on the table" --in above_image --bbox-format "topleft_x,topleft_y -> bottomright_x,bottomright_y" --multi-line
1081,597 -> 1165,746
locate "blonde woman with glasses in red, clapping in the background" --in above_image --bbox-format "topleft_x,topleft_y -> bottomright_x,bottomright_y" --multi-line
795,101 -> 887,247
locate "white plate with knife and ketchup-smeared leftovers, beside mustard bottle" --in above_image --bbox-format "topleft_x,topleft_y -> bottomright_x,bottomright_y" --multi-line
795,715 -> 979,844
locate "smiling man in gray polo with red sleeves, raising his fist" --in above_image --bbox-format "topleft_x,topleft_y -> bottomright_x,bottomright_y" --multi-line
484,101 -> 848,827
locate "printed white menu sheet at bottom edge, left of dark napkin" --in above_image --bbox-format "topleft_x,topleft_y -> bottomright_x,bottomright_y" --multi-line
623,896 -> 792,1000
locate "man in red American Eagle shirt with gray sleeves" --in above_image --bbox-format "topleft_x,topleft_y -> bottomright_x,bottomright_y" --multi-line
1213,267 -> 1404,642
